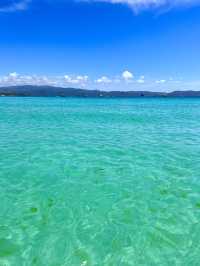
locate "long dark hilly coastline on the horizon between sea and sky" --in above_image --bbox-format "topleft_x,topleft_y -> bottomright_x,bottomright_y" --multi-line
0,85 -> 200,98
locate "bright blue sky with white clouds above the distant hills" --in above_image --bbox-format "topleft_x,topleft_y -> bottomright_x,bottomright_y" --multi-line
0,0 -> 200,91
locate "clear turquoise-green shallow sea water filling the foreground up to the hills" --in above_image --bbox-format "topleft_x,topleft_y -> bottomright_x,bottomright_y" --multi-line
0,97 -> 200,266
